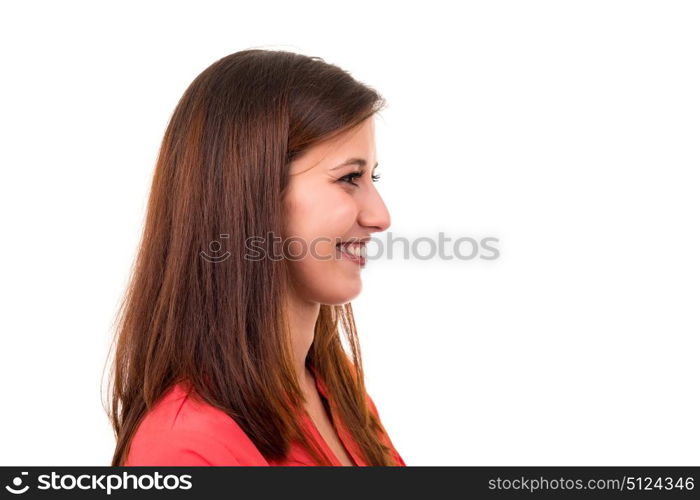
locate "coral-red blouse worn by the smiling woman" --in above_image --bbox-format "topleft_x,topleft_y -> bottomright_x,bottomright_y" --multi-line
124,370 -> 406,466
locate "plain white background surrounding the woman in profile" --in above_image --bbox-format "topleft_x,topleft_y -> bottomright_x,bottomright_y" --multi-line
0,0 -> 700,465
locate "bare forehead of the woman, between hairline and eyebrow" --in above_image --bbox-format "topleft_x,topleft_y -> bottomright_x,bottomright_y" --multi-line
289,117 -> 376,175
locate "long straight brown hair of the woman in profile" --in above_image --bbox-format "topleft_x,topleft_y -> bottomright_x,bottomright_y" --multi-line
103,49 -> 394,465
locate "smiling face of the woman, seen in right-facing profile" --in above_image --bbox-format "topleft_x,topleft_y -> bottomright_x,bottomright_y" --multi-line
283,117 -> 390,305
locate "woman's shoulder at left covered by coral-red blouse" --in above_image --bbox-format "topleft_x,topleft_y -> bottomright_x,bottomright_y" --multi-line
124,384 -> 268,466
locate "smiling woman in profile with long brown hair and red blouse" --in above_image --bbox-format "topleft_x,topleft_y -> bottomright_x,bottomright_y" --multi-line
110,50 -> 405,466
